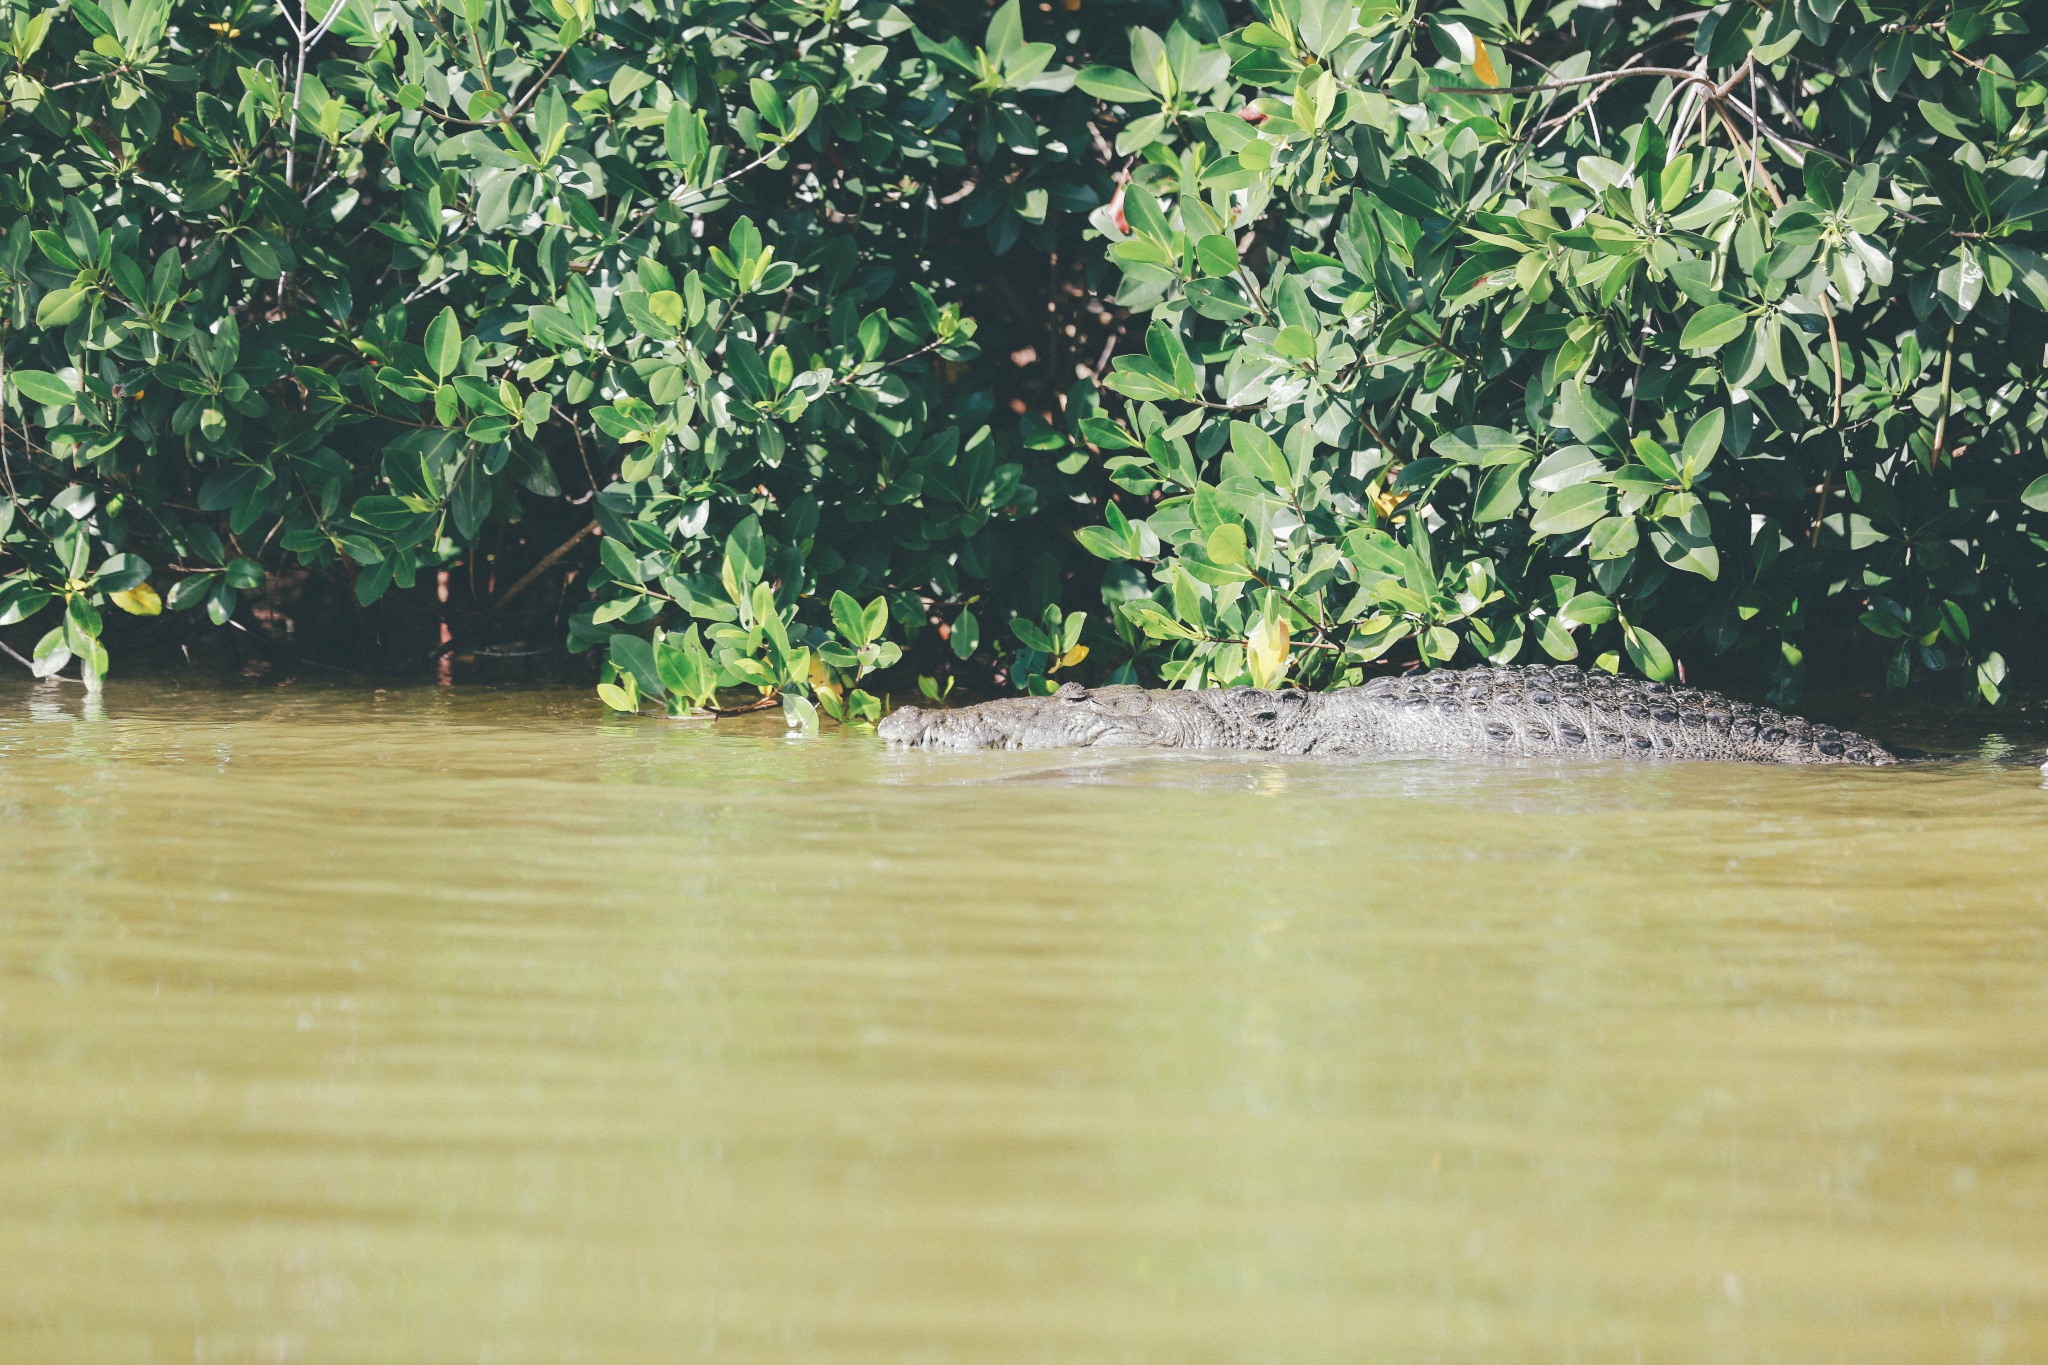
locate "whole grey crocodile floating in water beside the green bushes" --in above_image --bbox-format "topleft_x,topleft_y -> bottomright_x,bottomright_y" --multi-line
881,667 -> 1898,765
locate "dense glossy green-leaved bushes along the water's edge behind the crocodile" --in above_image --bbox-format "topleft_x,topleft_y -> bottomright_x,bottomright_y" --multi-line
0,0 -> 2048,729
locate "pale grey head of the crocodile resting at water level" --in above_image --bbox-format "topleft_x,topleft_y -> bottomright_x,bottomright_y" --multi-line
879,684 -> 1196,749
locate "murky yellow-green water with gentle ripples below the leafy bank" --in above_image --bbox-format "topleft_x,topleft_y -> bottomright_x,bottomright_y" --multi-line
0,681 -> 2048,1365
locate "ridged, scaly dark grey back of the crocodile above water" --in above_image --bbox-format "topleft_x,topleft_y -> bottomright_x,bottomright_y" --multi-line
1339,665 -> 1896,765
